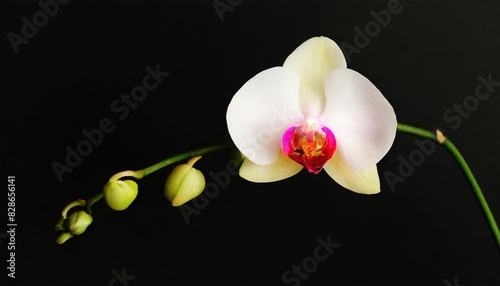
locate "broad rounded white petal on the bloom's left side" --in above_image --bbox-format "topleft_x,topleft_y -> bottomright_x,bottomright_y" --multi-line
226,67 -> 304,165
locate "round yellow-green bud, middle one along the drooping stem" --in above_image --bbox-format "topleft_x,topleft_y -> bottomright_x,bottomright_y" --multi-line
103,180 -> 139,211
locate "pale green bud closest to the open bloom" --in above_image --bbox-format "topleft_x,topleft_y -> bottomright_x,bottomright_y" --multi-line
165,156 -> 205,207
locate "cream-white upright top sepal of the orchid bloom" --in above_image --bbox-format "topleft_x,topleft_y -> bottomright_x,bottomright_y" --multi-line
283,37 -> 347,118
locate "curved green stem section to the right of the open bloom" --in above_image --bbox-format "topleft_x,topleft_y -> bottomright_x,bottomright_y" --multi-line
397,123 -> 500,248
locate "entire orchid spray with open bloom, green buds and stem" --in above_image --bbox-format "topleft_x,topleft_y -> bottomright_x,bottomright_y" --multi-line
54,37 -> 500,252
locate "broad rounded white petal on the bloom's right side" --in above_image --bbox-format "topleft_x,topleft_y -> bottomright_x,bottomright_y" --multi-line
320,69 -> 397,170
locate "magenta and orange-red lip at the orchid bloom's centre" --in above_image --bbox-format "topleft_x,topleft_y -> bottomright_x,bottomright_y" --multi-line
281,119 -> 337,174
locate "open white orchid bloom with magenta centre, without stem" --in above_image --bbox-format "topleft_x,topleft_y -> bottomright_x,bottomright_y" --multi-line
226,34 -> 397,194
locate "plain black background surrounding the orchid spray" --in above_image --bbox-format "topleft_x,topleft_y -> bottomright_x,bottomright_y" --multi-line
0,0 -> 500,286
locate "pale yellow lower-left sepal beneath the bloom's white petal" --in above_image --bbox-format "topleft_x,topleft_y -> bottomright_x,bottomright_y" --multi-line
240,154 -> 303,183
